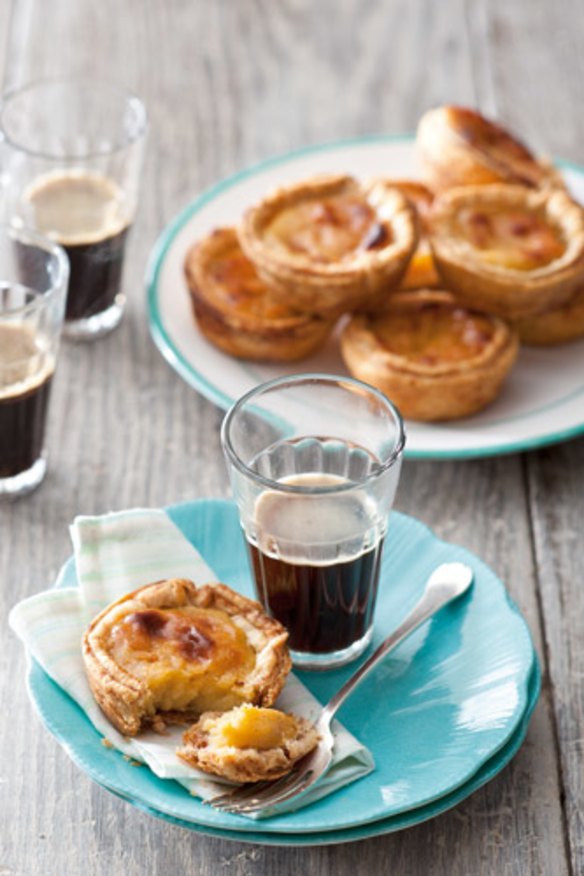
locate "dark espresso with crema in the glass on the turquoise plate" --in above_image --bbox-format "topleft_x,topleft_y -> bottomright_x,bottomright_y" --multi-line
247,474 -> 384,654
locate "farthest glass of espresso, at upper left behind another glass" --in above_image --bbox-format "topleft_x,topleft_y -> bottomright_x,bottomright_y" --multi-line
0,78 -> 147,340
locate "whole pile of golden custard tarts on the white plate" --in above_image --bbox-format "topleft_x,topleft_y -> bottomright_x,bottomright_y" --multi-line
185,106 -> 584,421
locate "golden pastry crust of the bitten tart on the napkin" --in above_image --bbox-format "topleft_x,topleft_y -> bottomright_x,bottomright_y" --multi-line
83,578 -> 291,736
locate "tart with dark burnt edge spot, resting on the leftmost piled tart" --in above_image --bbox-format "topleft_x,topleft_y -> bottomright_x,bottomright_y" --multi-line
239,174 -> 418,316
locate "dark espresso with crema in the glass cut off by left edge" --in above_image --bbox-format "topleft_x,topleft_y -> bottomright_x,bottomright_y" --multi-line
0,325 -> 54,478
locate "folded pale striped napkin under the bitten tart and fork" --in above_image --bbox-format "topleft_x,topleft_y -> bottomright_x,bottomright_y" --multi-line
10,509 -> 374,818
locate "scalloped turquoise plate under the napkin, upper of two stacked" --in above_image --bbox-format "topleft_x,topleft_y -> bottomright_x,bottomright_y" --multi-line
29,499 -> 539,836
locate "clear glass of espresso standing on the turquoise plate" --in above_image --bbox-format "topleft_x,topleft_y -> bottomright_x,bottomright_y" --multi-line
221,374 -> 405,669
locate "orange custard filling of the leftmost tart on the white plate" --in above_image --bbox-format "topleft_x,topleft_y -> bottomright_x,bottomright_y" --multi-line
206,242 -> 294,319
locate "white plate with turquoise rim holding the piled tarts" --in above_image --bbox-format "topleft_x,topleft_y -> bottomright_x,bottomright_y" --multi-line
147,137 -> 584,459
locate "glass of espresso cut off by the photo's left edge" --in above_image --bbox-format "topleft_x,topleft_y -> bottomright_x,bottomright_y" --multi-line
0,226 -> 69,499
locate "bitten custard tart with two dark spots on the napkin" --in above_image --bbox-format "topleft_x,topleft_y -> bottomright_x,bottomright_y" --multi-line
83,578 -> 291,736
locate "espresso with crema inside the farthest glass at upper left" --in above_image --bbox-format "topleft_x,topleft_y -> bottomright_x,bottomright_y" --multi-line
24,171 -> 129,321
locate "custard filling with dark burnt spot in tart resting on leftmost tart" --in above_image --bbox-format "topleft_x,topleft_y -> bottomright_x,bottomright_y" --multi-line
265,194 -> 392,263
